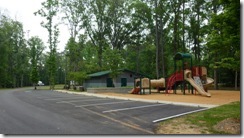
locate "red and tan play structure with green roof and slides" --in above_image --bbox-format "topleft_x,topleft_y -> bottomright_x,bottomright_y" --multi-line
130,53 -> 214,97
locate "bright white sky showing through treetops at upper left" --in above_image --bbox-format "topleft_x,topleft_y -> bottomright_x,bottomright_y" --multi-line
0,0 -> 69,52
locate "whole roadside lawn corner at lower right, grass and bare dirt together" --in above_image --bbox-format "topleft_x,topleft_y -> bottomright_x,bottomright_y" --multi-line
157,102 -> 241,134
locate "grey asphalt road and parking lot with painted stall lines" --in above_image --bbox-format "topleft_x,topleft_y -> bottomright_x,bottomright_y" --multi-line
0,89 -> 206,135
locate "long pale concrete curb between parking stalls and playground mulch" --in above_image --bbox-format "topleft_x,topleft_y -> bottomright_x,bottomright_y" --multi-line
55,90 -> 219,108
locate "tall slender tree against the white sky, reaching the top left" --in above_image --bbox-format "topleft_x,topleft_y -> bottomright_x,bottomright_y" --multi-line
34,0 -> 59,90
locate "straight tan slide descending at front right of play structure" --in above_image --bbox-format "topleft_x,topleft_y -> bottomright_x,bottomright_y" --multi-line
184,70 -> 211,97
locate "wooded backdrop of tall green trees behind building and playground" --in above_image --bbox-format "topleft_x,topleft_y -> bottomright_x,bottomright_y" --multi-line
0,0 -> 241,89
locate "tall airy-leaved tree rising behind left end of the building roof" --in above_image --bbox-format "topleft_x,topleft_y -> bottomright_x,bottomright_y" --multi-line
83,0 -> 109,68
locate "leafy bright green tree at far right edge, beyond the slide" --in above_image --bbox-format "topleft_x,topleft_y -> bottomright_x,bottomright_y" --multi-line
207,0 -> 240,89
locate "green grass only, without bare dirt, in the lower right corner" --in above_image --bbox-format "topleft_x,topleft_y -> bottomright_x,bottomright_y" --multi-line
161,102 -> 241,134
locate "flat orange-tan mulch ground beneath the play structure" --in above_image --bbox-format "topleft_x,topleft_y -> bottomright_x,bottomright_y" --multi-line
99,90 -> 240,105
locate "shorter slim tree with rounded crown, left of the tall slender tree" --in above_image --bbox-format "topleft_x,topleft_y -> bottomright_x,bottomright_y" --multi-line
28,36 -> 44,89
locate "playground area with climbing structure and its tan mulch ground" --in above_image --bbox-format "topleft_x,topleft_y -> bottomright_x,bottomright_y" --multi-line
90,53 -> 240,105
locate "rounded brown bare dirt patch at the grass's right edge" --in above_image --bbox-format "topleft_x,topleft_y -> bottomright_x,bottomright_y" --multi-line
214,118 -> 241,134
